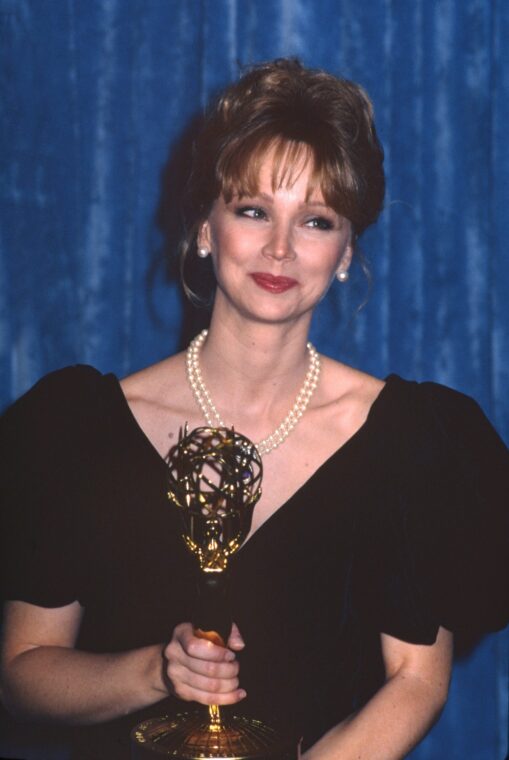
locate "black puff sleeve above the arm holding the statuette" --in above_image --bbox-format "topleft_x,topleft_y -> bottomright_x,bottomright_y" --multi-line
0,366 -> 101,607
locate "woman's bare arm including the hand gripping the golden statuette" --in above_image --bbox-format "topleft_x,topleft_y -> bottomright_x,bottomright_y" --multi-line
0,601 -> 243,724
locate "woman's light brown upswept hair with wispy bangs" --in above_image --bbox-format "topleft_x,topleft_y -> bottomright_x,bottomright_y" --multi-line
182,59 -> 385,302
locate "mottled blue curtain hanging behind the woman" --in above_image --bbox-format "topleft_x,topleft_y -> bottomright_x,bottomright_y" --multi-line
0,0 -> 509,760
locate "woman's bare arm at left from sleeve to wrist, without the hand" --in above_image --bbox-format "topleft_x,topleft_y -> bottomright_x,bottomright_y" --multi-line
1,601 -> 168,723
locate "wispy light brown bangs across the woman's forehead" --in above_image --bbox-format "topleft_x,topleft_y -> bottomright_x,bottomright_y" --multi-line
216,135 -> 355,221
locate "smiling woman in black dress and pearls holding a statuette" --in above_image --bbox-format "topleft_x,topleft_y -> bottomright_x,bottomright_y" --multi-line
2,60 -> 509,760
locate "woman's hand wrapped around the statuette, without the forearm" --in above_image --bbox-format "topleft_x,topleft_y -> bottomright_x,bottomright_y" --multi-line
163,623 -> 246,705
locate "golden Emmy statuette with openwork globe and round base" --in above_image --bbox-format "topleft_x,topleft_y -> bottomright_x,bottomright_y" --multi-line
131,427 -> 297,760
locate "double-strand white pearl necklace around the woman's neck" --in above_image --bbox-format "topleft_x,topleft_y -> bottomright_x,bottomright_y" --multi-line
186,330 -> 320,456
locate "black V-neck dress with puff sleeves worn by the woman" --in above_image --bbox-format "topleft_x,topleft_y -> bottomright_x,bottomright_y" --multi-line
1,366 -> 509,760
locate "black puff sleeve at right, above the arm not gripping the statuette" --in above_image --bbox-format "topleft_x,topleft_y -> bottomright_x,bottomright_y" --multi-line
361,376 -> 509,643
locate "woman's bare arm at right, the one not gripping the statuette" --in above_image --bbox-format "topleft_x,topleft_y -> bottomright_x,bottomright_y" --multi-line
304,628 -> 452,760
